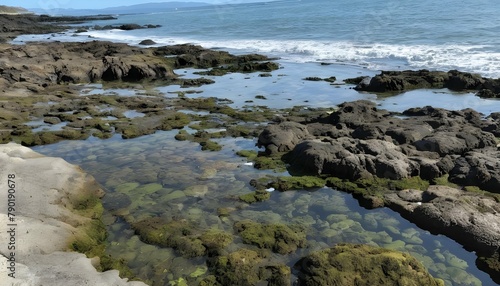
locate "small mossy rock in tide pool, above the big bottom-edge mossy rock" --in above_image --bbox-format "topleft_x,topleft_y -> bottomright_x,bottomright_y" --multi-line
234,220 -> 306,254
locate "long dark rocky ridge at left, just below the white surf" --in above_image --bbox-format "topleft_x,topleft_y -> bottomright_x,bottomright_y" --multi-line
0,41 -> 280,92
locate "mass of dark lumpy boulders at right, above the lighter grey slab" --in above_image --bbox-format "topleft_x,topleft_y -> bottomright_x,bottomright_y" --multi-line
258,101 -> 500,192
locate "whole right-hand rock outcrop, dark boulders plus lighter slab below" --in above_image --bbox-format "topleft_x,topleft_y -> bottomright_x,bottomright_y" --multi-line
258,101 -> 500,264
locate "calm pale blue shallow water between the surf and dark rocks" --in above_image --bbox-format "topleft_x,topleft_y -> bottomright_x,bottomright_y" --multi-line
156,61 -> 500,115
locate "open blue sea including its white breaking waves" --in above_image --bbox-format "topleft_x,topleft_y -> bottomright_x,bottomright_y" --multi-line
20,0 -> 500,78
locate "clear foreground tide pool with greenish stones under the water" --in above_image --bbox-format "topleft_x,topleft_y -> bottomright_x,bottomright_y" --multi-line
34,131 -> 494,285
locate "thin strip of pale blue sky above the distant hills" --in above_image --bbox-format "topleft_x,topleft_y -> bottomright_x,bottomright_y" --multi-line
4,0 -> 261,9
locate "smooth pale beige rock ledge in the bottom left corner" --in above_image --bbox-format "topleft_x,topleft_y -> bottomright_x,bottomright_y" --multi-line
0,143 -> 146,286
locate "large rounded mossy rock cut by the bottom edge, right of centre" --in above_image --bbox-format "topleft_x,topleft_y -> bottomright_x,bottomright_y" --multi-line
295,244 -> 444,286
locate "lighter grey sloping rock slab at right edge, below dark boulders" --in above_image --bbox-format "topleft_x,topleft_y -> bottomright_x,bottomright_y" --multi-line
384,185 -> 500,256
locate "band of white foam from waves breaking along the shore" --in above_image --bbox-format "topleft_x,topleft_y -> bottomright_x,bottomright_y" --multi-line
10,29 -> 500,78
